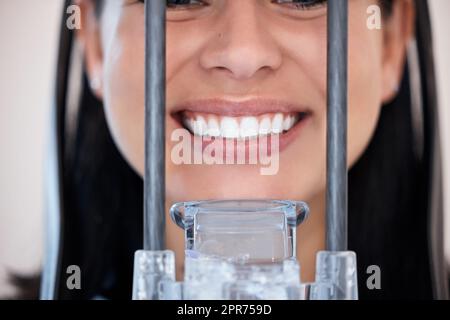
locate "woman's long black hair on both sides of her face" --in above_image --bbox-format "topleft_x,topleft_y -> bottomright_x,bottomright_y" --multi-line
43,0 -> 447,299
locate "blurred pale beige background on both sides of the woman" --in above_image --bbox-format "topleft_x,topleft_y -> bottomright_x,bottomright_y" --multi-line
0,0 -> 450,297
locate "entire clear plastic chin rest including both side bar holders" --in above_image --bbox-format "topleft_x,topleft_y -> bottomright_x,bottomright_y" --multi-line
129,200 -> 358,300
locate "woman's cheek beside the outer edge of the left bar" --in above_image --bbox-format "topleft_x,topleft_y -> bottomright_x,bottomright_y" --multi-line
104,13 -> 144,174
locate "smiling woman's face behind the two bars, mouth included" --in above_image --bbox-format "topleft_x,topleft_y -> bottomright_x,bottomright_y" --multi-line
80,0 -> 411,208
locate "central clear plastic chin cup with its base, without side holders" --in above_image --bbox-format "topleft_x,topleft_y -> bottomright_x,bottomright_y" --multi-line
171,200 -> 309,300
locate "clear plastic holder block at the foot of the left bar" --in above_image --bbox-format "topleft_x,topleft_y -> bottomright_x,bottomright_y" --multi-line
133,250 -> 175,300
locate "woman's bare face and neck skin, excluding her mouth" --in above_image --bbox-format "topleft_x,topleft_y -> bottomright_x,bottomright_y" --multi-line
78,0 -> 414,281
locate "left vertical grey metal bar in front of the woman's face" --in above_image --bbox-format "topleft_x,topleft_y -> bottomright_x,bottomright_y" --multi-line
144,0 -> 166,250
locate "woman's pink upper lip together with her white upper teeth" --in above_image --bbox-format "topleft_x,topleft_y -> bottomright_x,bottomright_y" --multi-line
174,100 -> 311,140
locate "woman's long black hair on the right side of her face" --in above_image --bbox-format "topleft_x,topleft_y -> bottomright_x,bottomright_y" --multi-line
349,1 -> 447,299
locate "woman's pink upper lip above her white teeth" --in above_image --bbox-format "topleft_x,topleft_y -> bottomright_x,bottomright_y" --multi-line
172,98 -> 310,117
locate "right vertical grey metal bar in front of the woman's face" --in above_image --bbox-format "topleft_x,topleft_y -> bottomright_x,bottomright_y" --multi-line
326,0 -> 348,251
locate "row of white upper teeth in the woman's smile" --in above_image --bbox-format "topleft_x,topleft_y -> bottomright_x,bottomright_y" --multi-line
183,113 -> 299,139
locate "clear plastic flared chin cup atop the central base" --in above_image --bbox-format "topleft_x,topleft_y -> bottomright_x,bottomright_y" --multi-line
171,200 -> 309,263
